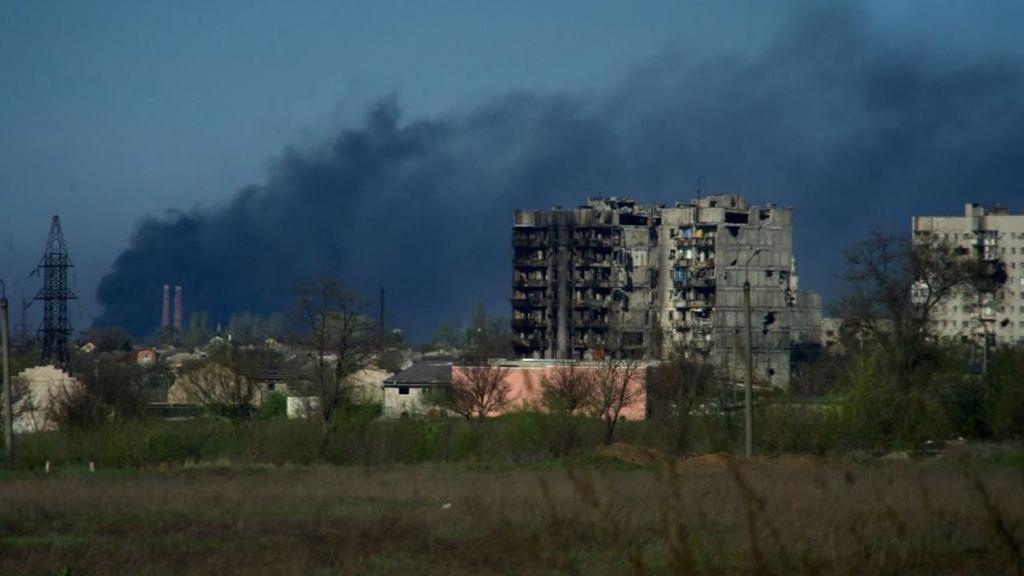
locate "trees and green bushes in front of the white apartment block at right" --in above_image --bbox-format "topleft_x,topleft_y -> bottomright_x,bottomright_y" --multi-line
795,233 -> 1024,447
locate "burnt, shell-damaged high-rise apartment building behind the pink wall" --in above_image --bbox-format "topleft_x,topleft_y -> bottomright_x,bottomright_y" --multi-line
512,195 -> 821,386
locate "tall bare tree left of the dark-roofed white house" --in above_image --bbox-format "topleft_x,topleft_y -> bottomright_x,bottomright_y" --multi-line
296,278 -> 377,425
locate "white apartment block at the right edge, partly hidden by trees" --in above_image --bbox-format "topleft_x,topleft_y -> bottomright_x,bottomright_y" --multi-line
913,204 -> 1024,345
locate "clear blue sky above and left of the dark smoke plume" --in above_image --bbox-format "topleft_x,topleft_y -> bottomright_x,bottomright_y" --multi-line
0,0 -> 1024,336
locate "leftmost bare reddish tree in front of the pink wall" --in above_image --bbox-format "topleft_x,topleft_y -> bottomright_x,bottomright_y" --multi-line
451,342 -> 515,420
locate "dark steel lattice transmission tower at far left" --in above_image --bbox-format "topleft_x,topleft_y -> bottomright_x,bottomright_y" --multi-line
33,216 -> 78,368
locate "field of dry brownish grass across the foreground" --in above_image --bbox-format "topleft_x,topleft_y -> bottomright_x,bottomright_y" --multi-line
0,456 -> 1024,575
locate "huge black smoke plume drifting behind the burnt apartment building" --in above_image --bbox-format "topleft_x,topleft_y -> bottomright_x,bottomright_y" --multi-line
97,4 -> 1024,338
